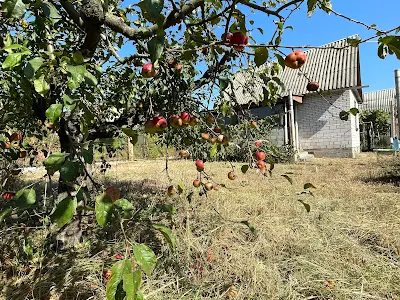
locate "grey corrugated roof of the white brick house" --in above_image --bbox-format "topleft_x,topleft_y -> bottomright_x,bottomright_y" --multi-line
228,36 -> 361,104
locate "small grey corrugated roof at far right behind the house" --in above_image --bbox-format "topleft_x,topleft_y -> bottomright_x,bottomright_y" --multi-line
359,88 -> 397,113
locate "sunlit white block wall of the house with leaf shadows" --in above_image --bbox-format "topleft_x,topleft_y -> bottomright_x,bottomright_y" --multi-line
295,90 -> 360,157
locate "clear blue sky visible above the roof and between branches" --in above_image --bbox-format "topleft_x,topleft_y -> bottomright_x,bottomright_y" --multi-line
121,0 -> 400,92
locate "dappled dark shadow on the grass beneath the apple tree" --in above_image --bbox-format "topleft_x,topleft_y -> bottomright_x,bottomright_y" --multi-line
0,180 -> 179,300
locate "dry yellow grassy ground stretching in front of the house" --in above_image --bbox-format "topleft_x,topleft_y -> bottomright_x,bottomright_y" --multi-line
0,155 -> 400,300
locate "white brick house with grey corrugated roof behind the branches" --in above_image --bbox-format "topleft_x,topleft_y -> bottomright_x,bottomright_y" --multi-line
227,36 -> 363,157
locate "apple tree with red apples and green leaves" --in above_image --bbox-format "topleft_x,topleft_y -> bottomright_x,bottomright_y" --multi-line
0,0 -> 400,299
